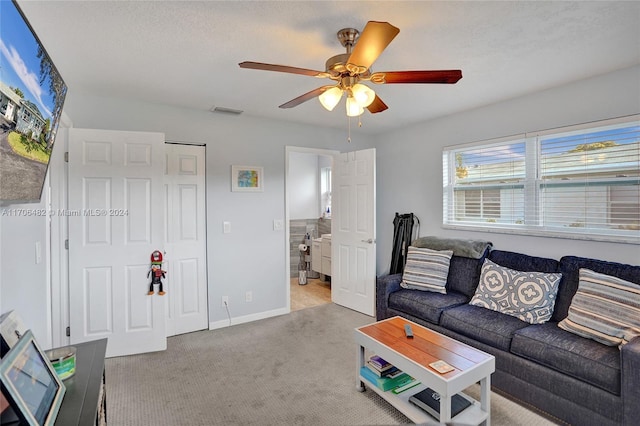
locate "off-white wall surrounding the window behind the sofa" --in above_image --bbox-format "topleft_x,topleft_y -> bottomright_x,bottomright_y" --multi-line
376,66 -> 640,274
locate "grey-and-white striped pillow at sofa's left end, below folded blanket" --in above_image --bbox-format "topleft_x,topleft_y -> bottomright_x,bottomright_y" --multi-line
400,246 -> 453,294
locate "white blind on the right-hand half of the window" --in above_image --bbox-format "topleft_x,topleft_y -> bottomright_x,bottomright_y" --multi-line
538,123 -> 640,235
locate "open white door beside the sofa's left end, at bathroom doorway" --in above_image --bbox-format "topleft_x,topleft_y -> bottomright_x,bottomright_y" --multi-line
331,149 -> 376,316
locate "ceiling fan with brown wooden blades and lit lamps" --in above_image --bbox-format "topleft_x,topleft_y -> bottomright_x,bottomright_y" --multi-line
238,21 -> 462,117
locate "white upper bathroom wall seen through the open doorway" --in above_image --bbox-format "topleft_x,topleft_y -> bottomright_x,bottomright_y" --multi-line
287,151 -> 321,220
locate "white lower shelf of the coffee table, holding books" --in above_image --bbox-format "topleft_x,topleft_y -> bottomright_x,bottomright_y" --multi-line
360,376 -> 488,424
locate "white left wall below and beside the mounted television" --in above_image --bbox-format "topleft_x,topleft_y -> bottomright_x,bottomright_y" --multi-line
0,115 -> 71,349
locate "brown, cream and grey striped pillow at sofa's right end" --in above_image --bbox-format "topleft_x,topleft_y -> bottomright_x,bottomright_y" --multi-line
558,269 -> 640,346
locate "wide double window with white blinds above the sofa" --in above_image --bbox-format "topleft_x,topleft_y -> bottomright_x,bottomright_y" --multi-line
442,116 -> 640,243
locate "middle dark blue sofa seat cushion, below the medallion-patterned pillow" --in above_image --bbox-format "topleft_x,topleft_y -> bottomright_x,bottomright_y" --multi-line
440,305 -> 529,351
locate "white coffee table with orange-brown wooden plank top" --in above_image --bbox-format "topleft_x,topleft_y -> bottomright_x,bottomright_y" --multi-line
355,317 -> 495,426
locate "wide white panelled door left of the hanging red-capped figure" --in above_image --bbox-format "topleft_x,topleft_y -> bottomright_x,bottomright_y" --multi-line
67,128 -> 167,357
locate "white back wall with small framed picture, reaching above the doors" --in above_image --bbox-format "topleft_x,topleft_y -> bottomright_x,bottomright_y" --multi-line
61,93 -> 370,327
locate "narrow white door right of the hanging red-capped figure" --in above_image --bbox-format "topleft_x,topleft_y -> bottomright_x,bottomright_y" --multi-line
164,144 -> 209,336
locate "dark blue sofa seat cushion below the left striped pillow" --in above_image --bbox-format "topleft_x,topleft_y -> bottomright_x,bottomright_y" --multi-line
389,290 -> 469,324
